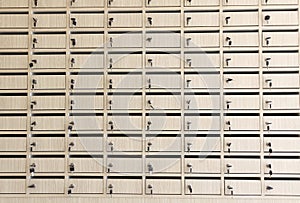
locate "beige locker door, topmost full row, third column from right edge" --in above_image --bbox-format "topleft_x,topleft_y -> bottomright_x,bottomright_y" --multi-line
184,12 -> 220,27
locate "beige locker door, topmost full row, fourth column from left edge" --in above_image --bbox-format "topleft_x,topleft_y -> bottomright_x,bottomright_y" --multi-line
108,13 -> 142,28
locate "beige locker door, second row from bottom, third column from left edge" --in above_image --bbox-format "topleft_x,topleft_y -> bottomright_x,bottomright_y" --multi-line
68,157 -> 103,173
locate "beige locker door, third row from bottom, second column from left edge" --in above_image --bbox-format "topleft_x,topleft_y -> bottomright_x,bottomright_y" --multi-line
30,137 -> 65,152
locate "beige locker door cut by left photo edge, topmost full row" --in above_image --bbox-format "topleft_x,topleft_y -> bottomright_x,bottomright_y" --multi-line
0,14 -> 28,28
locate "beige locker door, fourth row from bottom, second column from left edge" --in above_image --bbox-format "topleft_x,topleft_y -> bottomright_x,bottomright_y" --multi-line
30,116 -> 65,131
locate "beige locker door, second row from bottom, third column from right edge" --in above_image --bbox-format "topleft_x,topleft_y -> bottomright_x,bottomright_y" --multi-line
184,157 -> 221,174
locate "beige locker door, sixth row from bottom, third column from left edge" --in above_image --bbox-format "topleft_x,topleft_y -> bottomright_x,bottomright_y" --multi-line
70,73 -> 103,90
